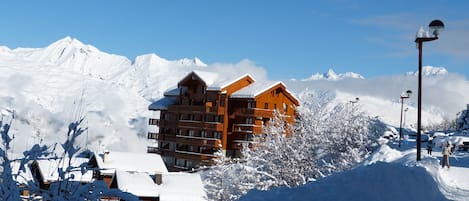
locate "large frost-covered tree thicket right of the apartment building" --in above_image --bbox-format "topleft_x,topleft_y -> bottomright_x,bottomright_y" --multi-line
201,91 -> 384,200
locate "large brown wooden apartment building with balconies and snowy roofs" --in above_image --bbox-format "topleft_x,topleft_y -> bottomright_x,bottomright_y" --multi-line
148,71 -> 299,170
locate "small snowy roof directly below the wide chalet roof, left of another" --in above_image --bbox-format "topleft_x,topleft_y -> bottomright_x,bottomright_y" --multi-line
114,171 -> 161,200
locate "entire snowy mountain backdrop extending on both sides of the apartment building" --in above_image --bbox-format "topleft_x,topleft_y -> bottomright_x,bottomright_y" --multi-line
0,37 -> 469,155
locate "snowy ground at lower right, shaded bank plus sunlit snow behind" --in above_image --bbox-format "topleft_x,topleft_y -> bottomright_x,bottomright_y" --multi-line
240,133 -> 469,201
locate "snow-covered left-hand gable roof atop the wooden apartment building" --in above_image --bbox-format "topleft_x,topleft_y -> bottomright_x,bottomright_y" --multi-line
178,70 -> 254,91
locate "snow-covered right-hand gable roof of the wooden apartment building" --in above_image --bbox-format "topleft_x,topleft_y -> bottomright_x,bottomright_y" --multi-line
230,81 -> 299,104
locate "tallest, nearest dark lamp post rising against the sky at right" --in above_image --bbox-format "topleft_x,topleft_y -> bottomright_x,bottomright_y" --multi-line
415,20 -> 445,161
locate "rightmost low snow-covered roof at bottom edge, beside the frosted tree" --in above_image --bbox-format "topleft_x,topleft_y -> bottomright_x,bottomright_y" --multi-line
160,172 -> 205,201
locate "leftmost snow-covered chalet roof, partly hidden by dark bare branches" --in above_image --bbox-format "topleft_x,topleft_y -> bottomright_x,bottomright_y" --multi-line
35,158 -> 93,182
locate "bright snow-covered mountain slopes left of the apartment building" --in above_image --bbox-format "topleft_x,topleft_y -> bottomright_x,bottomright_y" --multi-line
0,37 -> 207,154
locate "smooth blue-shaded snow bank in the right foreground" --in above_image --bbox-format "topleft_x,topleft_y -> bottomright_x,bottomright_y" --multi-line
240,158 -> 448,201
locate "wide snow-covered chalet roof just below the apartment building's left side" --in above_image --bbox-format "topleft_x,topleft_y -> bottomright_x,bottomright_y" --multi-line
95,151 -> 168,174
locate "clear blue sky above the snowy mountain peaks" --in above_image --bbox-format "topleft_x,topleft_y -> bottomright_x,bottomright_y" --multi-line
0,0 -> 469,79
